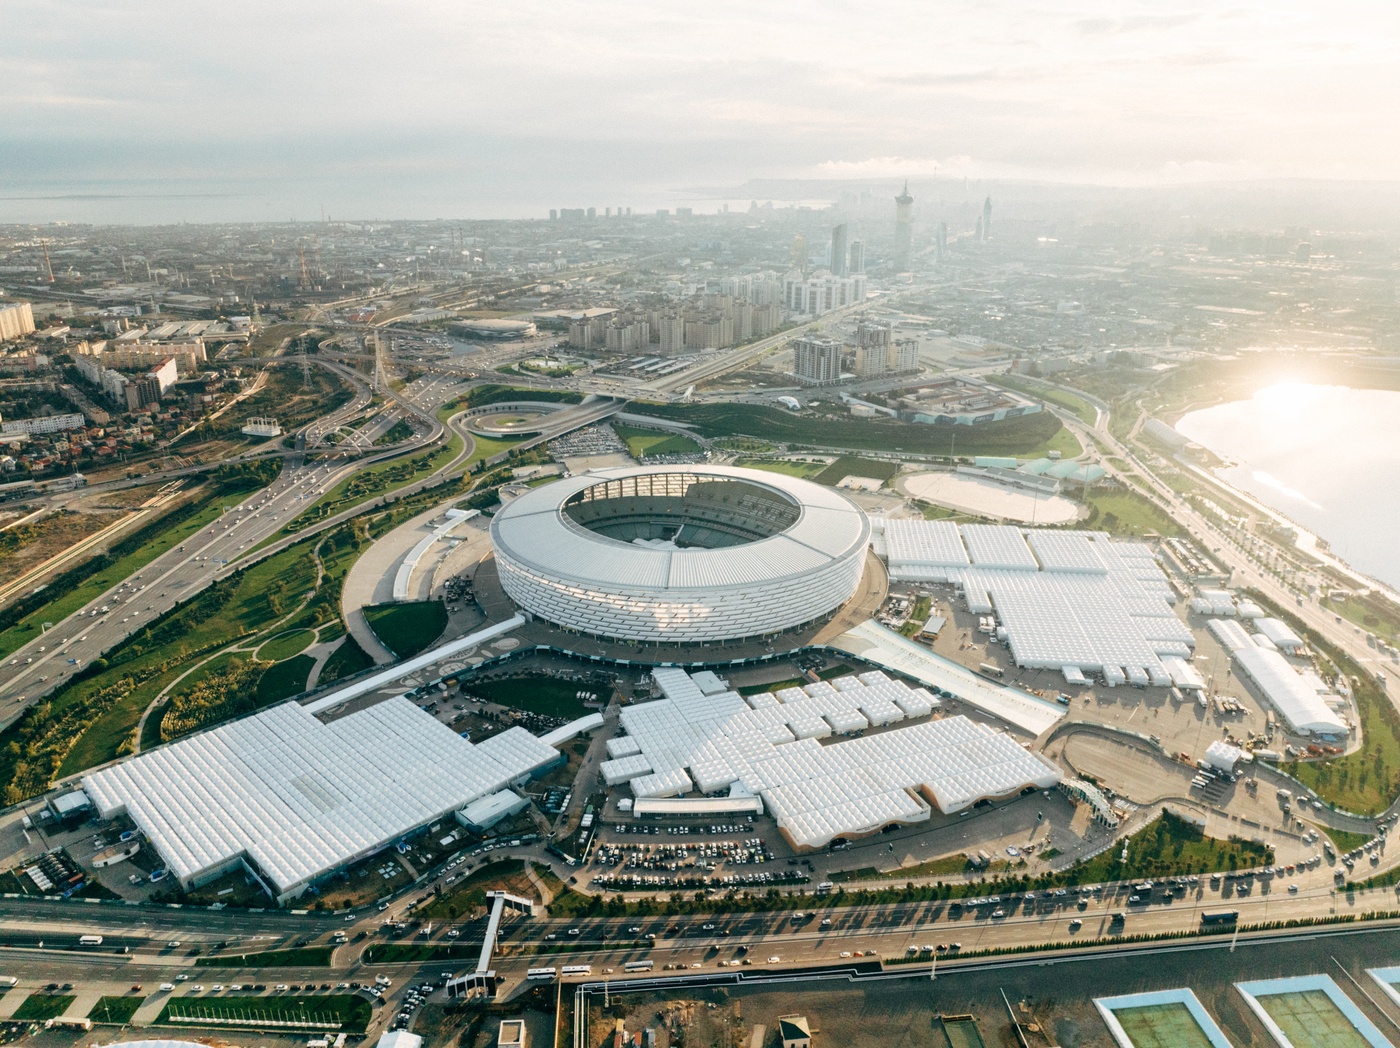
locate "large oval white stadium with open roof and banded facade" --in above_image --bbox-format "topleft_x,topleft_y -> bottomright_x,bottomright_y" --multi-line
491,466 -> 871,644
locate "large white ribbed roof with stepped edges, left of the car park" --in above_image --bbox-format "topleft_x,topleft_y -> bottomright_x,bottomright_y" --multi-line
84,698 -> 559,898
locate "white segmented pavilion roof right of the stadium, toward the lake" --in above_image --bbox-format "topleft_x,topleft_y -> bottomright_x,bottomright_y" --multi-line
882,521 -> 1194,686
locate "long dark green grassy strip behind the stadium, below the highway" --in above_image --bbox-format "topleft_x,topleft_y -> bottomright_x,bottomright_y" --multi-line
627,403 -> 1082,458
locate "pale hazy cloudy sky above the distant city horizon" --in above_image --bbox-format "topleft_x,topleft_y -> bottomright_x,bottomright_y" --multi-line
0,0 -> 1400,218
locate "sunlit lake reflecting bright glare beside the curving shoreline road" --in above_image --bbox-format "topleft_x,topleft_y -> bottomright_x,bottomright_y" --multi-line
1176,383 -> 1400,588
